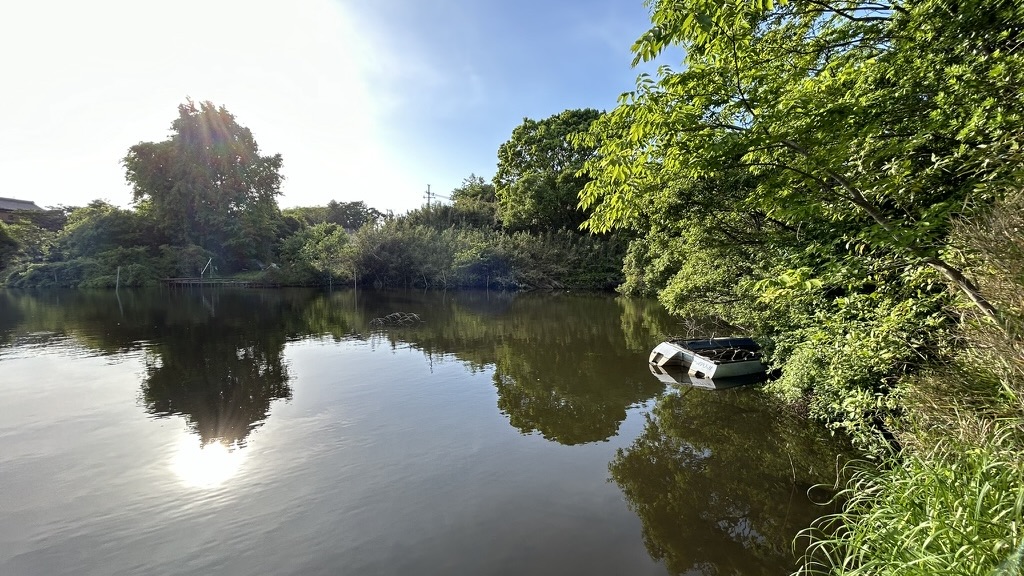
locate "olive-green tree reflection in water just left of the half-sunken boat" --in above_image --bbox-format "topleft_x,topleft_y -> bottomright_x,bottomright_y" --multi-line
364,292 -> 668,445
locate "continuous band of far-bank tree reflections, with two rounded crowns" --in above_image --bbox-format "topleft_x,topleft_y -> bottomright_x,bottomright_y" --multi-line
0,289 -> 684,446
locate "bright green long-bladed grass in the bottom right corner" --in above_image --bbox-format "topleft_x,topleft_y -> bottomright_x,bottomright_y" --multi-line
798,420 -> 1024,576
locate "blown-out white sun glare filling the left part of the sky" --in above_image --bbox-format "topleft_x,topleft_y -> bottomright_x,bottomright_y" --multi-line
0,0 -> 411,209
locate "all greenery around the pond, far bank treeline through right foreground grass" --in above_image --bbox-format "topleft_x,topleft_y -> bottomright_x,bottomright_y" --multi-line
0,0 -> 1024,574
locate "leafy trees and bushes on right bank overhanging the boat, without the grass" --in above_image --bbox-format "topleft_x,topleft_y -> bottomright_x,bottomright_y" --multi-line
581,0 -> 1024,440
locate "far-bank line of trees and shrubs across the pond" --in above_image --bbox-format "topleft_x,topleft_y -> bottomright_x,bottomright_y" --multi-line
0,101 -> 626,290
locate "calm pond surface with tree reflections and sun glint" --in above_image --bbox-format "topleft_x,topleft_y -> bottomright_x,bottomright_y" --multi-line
0,290 -> 837,576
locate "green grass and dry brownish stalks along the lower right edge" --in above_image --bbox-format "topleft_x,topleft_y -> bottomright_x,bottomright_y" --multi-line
804,155 -> 1024,576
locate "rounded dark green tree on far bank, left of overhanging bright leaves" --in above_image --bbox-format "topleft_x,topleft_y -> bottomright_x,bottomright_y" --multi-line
494,109 -> 601,231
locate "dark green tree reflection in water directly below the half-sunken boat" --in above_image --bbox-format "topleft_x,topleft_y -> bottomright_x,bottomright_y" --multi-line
608,388 -> 836,575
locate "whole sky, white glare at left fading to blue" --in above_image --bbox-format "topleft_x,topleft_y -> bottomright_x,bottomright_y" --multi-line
0,0 -> 655,212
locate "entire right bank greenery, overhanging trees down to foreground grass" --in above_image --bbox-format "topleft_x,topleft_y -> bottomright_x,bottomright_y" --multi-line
580,0 -> 1024,574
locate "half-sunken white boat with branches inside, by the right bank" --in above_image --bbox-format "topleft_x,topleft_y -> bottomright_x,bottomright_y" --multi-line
649,338 -> 765,378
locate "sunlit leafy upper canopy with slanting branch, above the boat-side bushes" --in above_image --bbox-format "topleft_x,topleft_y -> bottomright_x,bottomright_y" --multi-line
583,0 -> 1024,317
